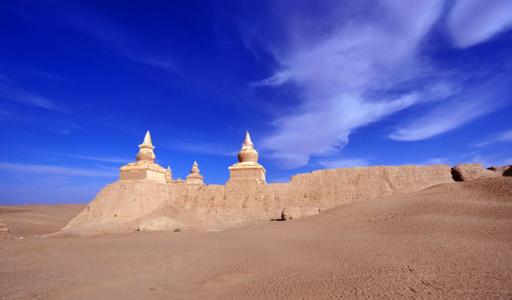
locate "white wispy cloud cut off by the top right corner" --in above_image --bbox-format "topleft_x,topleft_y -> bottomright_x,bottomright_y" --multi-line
448,0 -> 512,48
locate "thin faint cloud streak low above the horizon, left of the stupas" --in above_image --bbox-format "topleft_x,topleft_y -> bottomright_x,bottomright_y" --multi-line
0,162 -> 118,177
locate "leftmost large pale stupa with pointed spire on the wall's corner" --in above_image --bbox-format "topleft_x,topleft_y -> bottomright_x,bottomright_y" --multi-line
119,130 -> 167,183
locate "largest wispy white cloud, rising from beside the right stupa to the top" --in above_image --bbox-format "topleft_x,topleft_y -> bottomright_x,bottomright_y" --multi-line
257,0 -> 443,168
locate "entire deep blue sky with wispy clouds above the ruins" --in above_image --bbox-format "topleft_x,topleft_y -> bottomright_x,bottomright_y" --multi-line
0,0 -> 512,204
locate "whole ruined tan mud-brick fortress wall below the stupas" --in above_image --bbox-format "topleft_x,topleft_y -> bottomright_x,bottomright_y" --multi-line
65,165 -> 453,232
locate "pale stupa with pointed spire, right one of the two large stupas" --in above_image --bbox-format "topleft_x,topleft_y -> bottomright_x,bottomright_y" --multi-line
228,131 -> 266,184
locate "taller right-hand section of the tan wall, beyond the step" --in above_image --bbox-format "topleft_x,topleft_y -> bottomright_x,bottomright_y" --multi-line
287,165 -> 453,209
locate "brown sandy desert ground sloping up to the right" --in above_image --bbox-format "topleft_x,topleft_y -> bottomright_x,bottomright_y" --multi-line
0,177 -> 512,299
